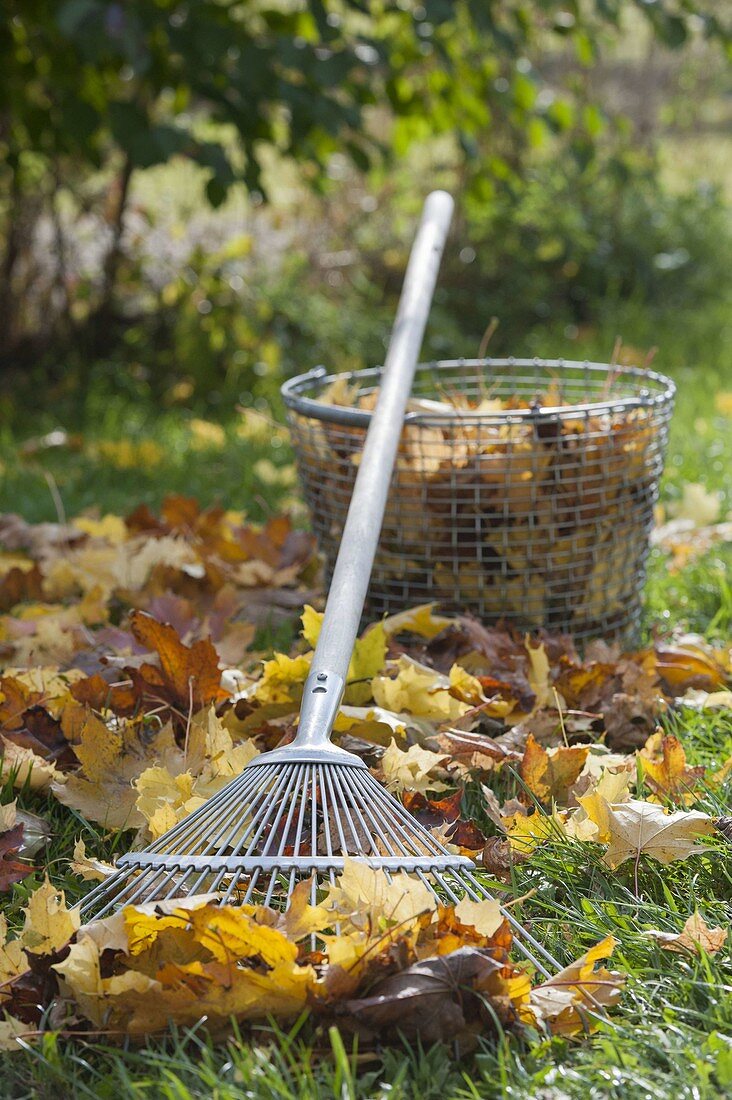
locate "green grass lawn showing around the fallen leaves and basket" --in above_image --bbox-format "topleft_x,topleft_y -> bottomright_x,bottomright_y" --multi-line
0,286 -> 732,1100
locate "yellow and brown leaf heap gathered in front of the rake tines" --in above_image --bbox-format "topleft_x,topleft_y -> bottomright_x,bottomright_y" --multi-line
0,861 -> 623,1047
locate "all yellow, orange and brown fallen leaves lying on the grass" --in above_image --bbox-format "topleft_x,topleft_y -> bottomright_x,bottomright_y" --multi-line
0,497 -> 732,1045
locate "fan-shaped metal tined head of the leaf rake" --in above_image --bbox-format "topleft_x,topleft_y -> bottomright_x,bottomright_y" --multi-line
81,746 -> 557,974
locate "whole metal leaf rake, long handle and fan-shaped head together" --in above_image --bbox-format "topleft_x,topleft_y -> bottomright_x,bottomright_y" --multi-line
83,191 -> 557,974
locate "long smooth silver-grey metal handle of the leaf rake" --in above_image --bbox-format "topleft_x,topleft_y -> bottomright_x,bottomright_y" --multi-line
289,191 -> 454,749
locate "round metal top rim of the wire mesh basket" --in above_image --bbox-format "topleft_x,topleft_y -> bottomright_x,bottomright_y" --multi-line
280,356 -> 676,428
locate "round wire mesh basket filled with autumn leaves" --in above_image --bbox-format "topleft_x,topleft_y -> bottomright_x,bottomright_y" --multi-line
282,359 -> 675,641
